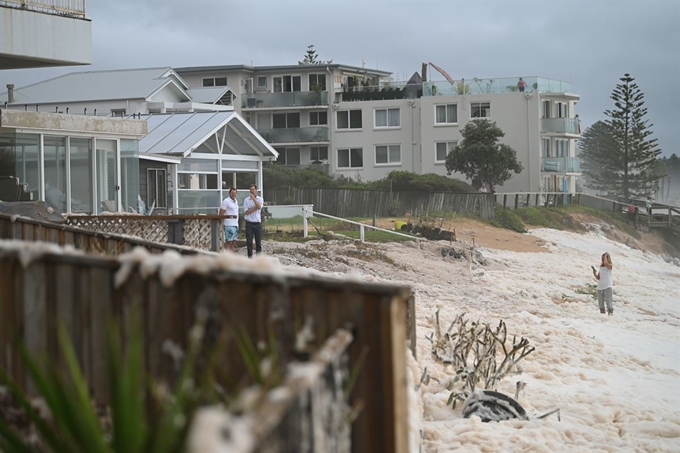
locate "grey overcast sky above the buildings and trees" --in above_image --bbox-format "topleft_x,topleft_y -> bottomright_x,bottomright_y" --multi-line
0,0 -> 680,155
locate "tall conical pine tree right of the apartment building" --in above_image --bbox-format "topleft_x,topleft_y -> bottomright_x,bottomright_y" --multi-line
581,74 -> 663,199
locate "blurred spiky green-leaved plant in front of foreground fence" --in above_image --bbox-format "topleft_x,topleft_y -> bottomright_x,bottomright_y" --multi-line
0,310 -> 210,453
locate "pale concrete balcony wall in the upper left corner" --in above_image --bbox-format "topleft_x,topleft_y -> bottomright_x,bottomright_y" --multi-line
0,6 -> 92,69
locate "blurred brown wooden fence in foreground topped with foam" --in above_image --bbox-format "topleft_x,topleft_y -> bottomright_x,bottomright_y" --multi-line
0,241 -> 411,452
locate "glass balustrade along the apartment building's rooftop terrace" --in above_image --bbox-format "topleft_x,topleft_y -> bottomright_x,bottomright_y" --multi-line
423,77 -> 571,96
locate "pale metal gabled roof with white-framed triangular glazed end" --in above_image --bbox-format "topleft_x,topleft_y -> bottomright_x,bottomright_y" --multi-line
139,111 -> 278,160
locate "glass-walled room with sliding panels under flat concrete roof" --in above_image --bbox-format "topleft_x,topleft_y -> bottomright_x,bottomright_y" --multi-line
0,132 -> 139,214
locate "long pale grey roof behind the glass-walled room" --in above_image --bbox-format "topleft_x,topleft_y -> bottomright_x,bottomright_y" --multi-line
0,67 -> 188,105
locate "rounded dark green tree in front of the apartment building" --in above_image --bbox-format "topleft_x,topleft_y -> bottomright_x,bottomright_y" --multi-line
446,120 -> 523,187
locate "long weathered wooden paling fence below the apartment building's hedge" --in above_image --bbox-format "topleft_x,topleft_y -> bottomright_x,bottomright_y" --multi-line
264,189 -> 495,219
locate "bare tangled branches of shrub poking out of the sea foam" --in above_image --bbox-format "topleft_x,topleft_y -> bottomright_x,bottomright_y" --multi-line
421,310 -> 535,409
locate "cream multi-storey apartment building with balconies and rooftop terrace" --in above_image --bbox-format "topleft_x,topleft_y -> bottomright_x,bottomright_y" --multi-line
175,64 -> 580,192
